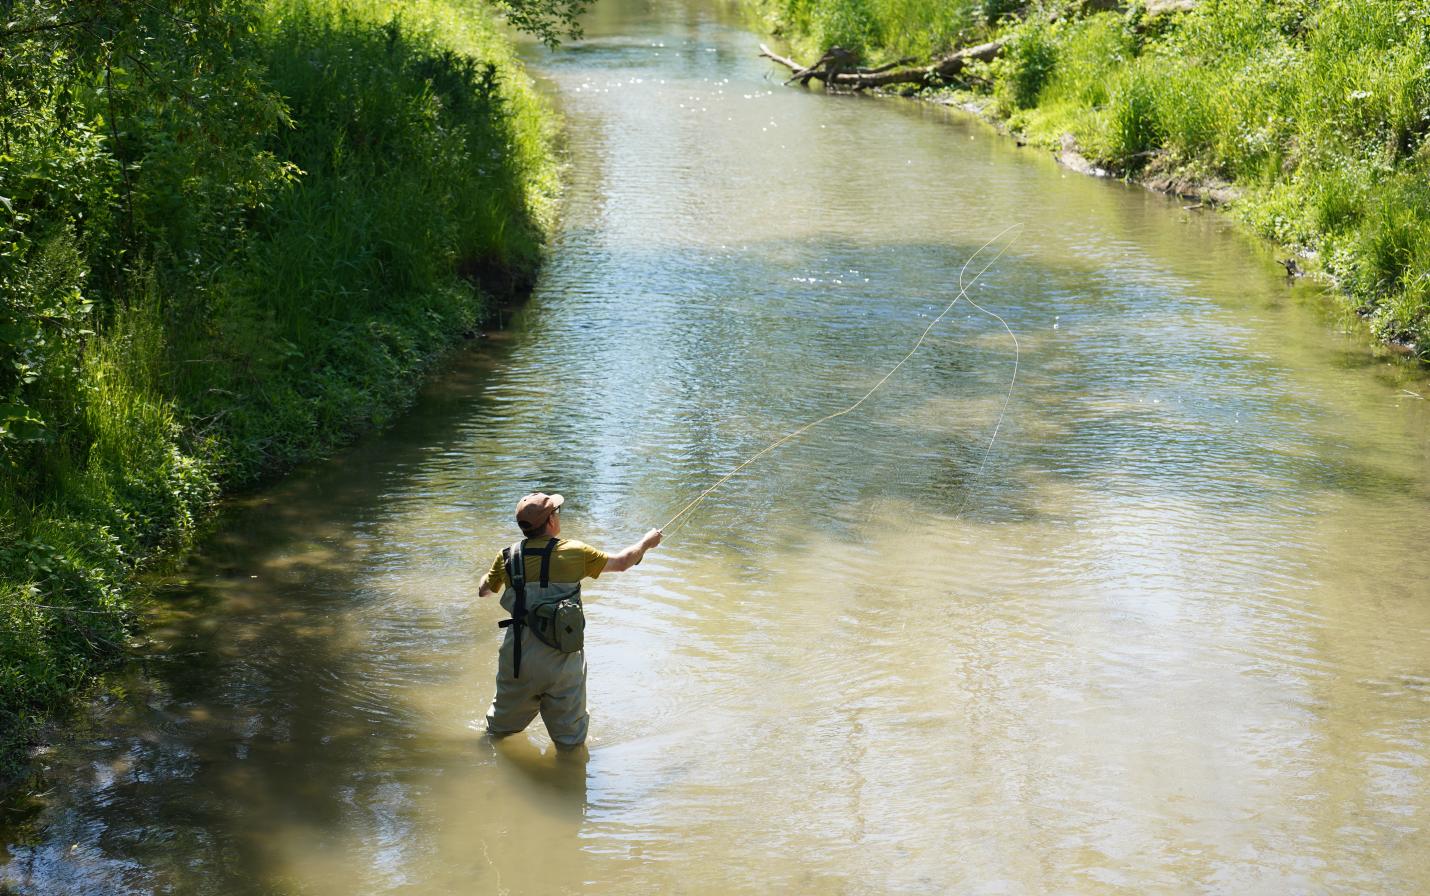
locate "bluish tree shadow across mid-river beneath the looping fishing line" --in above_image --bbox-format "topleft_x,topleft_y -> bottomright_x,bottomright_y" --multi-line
536,239 -> 1421,529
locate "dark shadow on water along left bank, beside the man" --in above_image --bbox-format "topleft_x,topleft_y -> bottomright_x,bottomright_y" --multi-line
0,337 -> 537,895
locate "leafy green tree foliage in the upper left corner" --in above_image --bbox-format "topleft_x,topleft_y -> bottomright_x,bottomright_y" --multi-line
0,0 -> 290,474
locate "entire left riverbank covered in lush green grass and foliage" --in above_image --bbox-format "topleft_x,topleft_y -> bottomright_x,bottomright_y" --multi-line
0,0 -> 556,769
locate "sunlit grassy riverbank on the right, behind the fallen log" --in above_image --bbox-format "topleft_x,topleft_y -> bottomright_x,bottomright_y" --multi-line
756,0 -> 1430,359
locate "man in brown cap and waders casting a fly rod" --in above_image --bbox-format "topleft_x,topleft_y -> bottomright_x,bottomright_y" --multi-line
476,492 -> 661,747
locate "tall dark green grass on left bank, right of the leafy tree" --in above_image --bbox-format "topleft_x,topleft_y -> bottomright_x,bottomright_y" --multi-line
180,1 -> 553,482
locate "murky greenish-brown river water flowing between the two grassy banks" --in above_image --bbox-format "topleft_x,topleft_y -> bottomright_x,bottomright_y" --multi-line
0,0 -> 1430,896
